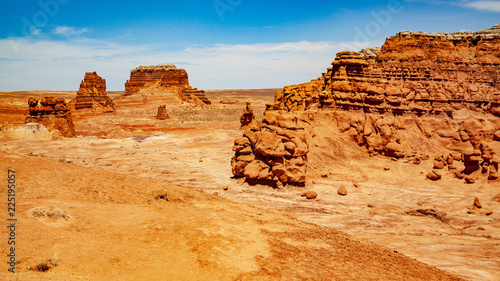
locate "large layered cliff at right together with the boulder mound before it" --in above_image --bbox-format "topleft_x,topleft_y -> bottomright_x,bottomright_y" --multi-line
232,25 -> 500,186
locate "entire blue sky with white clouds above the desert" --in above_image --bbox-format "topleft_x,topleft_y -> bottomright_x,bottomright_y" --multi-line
0,0 -> 500,91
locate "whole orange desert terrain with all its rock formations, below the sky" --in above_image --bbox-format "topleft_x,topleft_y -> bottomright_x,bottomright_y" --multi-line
0,25 -> 500,280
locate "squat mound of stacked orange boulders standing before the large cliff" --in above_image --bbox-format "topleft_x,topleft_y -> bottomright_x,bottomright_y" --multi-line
231,111 -> 313,186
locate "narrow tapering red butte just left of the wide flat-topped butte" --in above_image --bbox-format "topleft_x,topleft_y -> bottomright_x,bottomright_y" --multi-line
75,71 -> 115,113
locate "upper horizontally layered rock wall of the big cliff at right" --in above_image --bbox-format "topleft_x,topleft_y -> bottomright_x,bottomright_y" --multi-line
274,25 -> 500,116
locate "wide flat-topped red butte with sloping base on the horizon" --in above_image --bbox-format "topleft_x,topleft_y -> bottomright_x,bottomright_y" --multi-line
123,64 -> 211,105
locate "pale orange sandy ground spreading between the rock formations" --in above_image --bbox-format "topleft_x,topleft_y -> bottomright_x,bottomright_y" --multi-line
0,90 -> 500,280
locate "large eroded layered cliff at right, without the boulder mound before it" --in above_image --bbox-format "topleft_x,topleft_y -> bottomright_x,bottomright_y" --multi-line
235,25 -> 500,185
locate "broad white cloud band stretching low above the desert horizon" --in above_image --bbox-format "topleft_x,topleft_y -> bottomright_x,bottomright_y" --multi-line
0,38 -> 376,91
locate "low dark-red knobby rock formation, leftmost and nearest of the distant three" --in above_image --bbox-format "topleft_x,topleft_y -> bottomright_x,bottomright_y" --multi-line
25,97 -> 76,137
